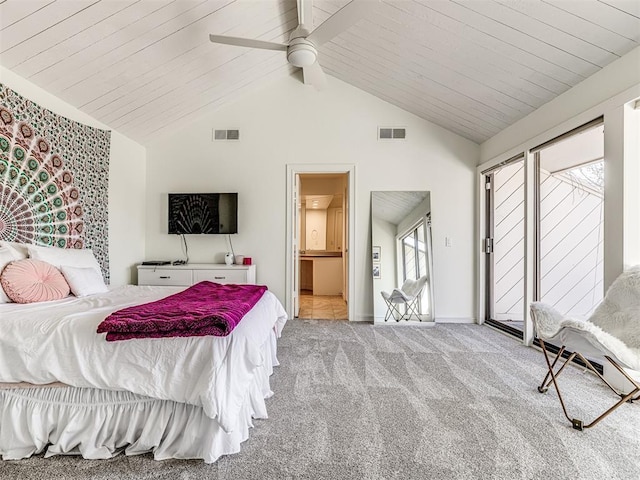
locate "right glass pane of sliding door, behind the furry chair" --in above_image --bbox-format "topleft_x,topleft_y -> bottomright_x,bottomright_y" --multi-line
535,121 -> 604,317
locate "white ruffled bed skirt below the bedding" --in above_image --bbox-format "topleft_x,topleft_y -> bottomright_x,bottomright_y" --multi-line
0,334 -> 278,463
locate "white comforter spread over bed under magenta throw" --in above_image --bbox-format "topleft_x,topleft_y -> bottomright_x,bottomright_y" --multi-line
0,286 -> 287,431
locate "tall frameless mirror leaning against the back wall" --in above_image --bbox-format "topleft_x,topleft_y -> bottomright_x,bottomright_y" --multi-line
371,191 -> 434,324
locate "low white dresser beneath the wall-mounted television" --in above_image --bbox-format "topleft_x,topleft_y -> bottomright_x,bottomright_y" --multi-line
138,263 -> 256,286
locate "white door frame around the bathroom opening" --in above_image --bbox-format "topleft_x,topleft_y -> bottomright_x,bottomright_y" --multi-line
285,163 -> 356,321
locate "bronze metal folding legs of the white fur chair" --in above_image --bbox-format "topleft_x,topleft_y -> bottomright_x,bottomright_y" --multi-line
538,340 -> 640,430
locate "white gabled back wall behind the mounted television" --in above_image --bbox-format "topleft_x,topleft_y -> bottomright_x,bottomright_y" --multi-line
146,77 -> 479,321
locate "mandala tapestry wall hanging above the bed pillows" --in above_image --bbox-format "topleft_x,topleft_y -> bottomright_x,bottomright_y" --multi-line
0,84 -> 111,281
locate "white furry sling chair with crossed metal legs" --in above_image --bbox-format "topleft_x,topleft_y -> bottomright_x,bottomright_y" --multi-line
531,266 -> 640,430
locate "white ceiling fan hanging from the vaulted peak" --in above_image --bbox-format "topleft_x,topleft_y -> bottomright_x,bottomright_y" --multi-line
209,0 -> 379,90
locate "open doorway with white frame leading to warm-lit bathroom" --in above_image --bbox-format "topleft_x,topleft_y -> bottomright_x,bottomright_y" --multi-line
286,165 -> 354,320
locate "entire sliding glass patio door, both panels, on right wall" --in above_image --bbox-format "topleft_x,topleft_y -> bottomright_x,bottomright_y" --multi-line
481,118 -> 605,343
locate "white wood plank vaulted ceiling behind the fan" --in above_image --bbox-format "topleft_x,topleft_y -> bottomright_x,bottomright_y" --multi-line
0,0 -> 640,144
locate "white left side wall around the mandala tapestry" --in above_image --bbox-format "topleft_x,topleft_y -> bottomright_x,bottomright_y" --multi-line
0,66 -> 146,285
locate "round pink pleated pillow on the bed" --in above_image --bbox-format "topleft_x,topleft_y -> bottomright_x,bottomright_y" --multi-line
0,258 -> 69,303
